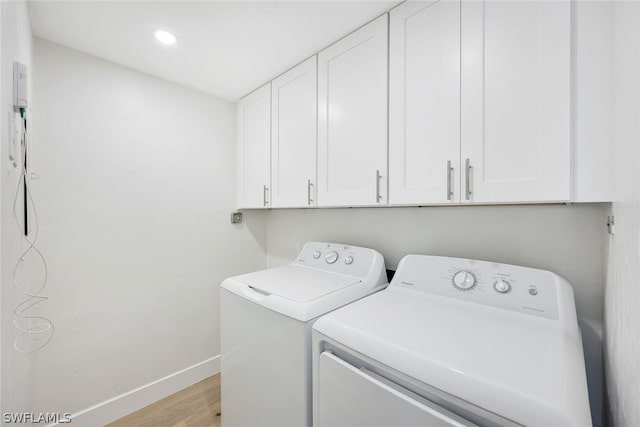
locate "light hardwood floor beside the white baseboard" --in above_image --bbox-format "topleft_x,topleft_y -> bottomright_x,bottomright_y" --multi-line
107,374 -> 220,427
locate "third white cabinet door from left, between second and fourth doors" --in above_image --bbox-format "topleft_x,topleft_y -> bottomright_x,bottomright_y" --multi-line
318,14 -> 388,206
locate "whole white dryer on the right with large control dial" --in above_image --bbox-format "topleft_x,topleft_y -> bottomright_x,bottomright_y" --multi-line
313,255 -> 591,427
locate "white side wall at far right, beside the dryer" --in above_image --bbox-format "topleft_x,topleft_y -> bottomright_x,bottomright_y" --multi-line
605,1 -> 640,427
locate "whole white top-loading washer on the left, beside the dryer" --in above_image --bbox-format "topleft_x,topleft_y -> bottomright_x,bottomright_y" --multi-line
220,242 -> 388,427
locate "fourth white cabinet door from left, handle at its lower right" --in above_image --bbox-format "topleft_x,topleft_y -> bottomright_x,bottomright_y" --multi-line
389,0 -> 460,205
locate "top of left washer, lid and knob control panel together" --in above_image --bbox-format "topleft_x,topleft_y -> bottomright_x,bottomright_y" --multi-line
221,242 -> 387,322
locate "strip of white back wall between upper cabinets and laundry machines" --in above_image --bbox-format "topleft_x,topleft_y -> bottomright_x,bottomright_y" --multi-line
266,204 -> 606,321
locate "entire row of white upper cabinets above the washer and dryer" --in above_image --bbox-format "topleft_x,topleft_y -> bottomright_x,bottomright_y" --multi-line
238,0 -> 592,208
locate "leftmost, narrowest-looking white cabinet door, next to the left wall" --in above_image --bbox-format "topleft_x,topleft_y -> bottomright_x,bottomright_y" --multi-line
237,83 -> 271,208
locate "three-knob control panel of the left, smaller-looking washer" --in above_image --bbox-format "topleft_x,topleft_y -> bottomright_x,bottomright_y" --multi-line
294,242 -> 378,277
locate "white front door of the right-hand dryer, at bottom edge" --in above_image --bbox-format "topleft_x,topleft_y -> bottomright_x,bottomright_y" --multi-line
317,351 -> 475,427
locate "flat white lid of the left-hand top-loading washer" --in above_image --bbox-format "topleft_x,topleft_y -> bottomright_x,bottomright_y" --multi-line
235,265 -> 362,303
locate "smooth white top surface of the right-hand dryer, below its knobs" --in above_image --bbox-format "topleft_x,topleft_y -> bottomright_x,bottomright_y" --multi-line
313,257 -> 590,425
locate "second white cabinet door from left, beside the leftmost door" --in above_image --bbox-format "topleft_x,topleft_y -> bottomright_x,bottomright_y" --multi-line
271,56 -> 318,208
